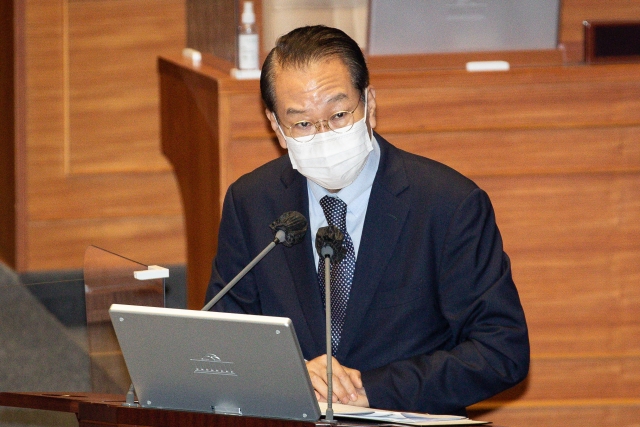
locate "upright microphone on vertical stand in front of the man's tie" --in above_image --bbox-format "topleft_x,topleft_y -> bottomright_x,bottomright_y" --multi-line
316,225 -> 347,421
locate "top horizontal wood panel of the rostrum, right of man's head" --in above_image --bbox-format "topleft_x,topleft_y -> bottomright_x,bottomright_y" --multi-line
371,65 -> 640,133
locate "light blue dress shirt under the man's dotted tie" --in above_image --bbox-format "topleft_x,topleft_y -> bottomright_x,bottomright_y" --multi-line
307,137 -> 380,270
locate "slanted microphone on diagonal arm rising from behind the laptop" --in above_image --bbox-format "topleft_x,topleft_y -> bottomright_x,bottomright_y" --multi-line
201,211 -> 307,311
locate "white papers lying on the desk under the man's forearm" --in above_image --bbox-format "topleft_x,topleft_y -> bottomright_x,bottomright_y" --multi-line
320,402 -> 489,426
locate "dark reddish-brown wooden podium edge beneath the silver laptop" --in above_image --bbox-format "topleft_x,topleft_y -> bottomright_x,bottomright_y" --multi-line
0,392 -> 332,427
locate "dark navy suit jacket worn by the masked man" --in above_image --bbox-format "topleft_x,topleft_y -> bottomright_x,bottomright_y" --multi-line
207,135 -> 529,414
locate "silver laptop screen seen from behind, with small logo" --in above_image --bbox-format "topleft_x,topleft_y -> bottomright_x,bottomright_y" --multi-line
109,304 -> 320,421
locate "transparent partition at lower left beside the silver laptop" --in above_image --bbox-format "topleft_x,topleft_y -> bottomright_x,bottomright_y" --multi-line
0,246 -> 165,402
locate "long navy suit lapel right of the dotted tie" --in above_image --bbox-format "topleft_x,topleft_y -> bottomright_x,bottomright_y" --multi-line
336,134 -> 409,359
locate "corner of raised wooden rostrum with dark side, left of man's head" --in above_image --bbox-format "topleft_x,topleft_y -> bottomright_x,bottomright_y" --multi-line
158,57 -> 282,309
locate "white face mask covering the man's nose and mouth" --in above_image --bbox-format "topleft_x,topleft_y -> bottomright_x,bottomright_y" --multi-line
278,98 -> 373,190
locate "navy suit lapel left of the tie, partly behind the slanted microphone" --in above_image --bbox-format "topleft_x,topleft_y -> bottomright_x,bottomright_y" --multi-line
281,165 -> 325,354
